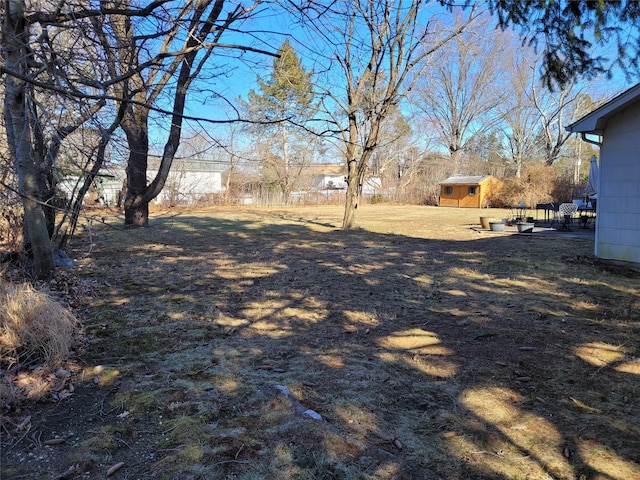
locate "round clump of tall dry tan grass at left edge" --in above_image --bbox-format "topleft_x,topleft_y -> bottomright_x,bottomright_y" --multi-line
0,280 -> 78,368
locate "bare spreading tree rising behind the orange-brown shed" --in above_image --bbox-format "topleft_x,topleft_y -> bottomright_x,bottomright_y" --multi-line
411,15 -> 507,177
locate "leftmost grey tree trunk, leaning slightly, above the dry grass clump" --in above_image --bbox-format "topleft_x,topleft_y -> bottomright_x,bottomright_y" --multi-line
3,1 -> 55,279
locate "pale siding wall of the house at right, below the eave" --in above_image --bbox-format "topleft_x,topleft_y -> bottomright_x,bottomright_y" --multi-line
595,103 -> 640,263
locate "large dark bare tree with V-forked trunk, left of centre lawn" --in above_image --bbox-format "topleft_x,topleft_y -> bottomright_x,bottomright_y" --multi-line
94,0 -> 266,226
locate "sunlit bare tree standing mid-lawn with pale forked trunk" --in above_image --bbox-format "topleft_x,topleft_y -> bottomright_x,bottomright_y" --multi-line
292,0 -> 478,230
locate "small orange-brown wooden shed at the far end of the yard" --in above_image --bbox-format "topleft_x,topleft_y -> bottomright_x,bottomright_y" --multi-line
439,175 -> 500,208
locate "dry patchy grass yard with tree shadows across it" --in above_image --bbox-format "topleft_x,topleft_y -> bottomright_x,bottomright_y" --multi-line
2,206 -> 640,480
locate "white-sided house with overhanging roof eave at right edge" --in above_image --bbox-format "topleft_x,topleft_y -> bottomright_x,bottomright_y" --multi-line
566,84 -> 640,267
